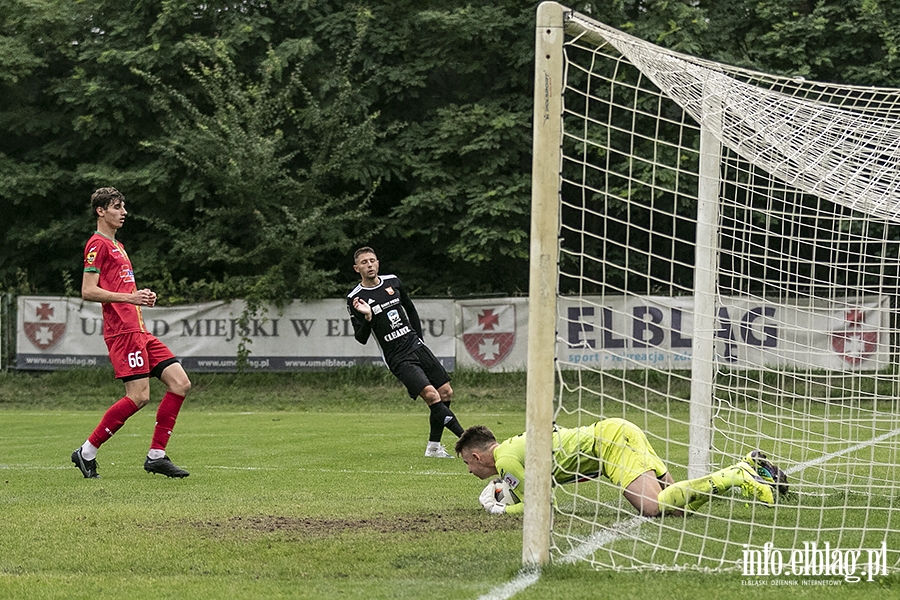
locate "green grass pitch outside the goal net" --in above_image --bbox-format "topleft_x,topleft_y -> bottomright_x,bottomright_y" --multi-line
0,371 -> 897,600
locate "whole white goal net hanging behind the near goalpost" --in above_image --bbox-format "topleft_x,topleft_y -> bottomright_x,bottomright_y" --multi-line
525,3 -> 900,581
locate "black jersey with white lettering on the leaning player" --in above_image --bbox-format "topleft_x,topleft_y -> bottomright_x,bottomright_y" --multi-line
347,275 -> 424,368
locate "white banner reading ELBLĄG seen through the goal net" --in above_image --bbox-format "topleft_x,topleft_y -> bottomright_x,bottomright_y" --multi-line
557,296 -> 891,370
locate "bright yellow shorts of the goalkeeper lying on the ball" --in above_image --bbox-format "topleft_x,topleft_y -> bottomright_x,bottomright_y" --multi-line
594,419 -> 668,489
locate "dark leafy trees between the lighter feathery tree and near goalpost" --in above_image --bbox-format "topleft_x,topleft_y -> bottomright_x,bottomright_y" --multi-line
348,0 -> 537,295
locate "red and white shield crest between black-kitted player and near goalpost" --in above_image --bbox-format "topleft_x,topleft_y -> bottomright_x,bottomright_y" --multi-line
462,304 -> 516,368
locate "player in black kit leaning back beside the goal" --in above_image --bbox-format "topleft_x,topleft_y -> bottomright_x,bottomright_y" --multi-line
347,246 -> 463,458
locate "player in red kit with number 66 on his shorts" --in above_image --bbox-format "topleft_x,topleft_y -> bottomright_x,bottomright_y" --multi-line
72,187 -> 191,479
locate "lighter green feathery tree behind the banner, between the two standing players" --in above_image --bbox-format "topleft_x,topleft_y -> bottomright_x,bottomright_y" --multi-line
137,33 -> 380,302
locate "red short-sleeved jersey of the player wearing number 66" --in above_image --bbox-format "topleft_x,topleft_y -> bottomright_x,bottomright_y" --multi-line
84,232 -> 147,339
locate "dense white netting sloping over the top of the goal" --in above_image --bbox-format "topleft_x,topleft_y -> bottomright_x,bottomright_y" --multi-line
572,14 -> 900,221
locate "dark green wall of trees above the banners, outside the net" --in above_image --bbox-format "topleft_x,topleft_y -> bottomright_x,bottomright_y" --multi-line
0,0 -> 900,303
